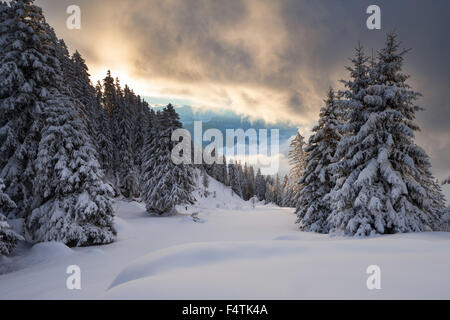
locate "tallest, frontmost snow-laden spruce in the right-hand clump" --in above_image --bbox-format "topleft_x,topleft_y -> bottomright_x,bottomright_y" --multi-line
328,34 -> 444,236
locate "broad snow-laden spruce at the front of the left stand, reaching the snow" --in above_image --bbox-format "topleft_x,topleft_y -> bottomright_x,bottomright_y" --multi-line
26,92 -> 116,246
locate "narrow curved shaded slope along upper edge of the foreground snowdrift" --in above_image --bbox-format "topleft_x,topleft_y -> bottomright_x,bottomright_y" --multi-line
110,241 -> 305,288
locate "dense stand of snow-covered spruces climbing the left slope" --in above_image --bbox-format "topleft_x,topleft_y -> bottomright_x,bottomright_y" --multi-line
0,0 -> 197,255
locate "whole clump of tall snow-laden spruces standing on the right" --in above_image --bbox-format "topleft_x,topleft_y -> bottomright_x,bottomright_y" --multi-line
297,39 -> 447,236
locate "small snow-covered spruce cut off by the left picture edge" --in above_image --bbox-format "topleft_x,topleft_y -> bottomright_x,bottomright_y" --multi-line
0,179 -> 22,256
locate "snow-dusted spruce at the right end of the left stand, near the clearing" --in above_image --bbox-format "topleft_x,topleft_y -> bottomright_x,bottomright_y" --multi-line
141,104 -> 195,215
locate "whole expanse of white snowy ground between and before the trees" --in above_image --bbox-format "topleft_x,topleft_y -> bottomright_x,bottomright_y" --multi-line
0,175 -> 450,299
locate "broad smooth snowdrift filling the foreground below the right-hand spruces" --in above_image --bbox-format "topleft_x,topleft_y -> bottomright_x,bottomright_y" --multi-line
103,233 -> 450,300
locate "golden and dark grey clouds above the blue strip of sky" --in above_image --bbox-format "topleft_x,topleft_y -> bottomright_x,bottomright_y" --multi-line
37,0 -> 450,195
